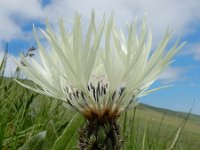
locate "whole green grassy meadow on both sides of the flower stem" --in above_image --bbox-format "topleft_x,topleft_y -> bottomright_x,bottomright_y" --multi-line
0,51 -> 200,150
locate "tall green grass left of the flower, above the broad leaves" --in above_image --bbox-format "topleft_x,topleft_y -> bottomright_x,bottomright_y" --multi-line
0,50 -> 73,149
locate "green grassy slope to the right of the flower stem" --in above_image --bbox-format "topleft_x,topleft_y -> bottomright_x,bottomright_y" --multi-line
120,104 -> 200,150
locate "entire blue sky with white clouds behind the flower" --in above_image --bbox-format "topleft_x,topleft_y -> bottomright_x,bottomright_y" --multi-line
0,0 -> 200,114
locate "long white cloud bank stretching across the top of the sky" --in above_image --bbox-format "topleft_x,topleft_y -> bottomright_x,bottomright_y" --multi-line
0,0 -> 200,41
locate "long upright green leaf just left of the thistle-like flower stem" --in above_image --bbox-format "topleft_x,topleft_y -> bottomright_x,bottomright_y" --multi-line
52,114 -> 84,150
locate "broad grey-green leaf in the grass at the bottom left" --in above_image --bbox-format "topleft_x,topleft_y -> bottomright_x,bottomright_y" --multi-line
18,131 -> 50,150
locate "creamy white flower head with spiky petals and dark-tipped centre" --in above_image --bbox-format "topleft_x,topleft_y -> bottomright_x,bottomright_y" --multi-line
16,12 -> 183,119
